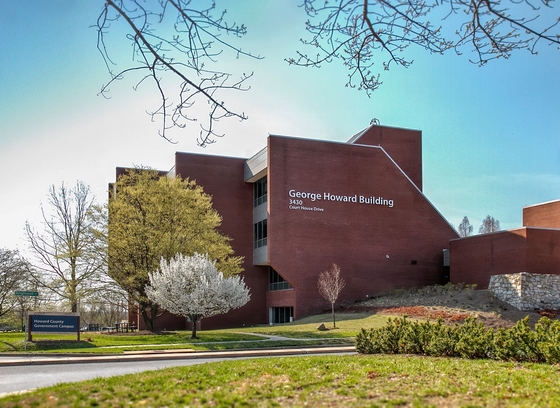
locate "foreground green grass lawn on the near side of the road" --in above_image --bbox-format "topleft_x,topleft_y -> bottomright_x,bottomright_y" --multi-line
0,355 -> 560,408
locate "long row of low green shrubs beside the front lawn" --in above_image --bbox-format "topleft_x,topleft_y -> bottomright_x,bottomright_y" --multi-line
356,317 -> 560,364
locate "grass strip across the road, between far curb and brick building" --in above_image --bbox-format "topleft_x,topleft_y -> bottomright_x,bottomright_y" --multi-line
0,313 -> 387,354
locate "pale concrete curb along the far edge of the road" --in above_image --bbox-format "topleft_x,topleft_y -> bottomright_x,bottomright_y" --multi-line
0,346 -> 356,367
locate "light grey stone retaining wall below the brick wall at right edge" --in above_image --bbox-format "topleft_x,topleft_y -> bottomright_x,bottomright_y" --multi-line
488,272 -> 560,311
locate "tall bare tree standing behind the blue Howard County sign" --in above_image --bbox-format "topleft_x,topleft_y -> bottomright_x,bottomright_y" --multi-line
25,182 -> 106,312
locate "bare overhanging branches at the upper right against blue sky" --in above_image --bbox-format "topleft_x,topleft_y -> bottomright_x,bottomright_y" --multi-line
287,0 -> 560,95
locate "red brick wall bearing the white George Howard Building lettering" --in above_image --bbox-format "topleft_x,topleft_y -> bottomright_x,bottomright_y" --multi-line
268,136 -> 457,319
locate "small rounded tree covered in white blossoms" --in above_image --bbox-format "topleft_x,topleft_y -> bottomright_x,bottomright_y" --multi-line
146,252 -> 251,339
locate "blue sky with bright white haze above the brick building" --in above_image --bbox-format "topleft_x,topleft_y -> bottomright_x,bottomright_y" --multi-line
0,0 -> 560,253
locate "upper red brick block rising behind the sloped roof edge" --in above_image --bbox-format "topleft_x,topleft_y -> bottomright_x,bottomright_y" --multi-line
348,126 -> 422,190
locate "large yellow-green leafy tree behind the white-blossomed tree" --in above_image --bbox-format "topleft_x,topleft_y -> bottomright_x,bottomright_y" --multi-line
108,169 -> 243,330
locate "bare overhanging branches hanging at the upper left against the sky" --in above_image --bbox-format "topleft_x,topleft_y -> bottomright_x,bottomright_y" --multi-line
97,0 -> 260,146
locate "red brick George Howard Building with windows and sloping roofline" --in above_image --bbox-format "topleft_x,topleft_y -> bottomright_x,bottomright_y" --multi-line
118,126 -> 457,329
